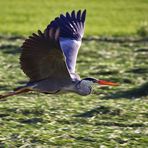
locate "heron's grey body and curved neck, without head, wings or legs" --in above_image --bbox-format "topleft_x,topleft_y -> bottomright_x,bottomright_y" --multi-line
18,72 -> 92,96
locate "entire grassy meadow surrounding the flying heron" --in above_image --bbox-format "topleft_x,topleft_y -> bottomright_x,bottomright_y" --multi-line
0,0 -> 148,148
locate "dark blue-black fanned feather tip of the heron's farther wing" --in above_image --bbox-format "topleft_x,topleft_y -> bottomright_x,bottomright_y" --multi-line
44,9 -> 86,40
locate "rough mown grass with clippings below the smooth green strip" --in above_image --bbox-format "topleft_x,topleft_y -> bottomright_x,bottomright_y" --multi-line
0,38 -> 148,148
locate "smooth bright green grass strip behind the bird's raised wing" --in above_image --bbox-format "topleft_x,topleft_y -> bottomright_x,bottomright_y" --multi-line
0,0 -> 148,36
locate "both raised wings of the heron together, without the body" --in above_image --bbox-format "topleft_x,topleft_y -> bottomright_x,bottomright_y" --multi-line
20,10 -> 86,82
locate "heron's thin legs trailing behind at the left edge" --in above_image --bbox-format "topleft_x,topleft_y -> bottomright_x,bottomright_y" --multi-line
0,86 -> 30,99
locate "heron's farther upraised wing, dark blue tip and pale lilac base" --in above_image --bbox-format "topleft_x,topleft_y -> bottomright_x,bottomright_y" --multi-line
44,10 -> 86,73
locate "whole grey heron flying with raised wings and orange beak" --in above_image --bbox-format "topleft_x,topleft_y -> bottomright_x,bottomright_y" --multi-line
0,10 -> 118,98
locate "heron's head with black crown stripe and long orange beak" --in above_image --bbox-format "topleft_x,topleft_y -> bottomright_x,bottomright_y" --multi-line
81,78 -> 119,86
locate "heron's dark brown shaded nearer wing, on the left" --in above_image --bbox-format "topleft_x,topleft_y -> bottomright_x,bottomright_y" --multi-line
20,28 -> 71,82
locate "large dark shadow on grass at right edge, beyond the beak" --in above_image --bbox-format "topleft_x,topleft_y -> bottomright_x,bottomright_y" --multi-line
103,82 -> 148,99
